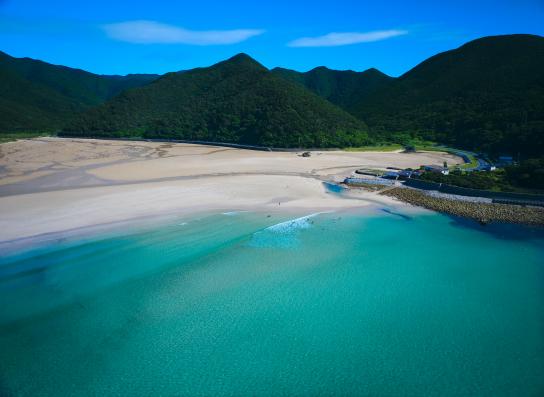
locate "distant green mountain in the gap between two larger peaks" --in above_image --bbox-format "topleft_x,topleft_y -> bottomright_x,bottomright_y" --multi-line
272,66 -> 394,111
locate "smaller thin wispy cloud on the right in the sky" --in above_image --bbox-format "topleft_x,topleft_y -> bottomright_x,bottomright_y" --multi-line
287,29 -> 408,47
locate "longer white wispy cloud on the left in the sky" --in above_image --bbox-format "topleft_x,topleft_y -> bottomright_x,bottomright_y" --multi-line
102,21 -> 264,45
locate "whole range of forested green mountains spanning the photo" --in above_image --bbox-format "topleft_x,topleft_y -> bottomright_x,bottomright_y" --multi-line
0,35 -> 544,155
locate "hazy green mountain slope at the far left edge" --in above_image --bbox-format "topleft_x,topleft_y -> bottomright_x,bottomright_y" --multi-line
0,52 -> 158,133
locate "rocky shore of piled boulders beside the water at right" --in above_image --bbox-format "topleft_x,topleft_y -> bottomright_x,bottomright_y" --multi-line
380,187 -> 544,226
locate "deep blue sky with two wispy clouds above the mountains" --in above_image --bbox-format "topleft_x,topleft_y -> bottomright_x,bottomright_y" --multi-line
0,0 -> 544,76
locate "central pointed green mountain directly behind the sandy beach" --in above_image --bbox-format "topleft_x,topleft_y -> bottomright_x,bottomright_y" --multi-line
63,54 -> 369,147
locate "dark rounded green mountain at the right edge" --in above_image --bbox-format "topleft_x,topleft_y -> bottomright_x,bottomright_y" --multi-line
354,35 -> 544,157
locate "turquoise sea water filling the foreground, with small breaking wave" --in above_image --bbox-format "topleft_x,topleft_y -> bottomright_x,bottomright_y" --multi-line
0,211 -> 544,396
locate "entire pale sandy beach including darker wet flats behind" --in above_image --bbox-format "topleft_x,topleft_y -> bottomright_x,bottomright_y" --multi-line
0,138 -> 462,242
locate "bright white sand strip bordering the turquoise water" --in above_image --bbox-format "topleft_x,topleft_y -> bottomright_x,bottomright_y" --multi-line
0,176 -> 408,243
